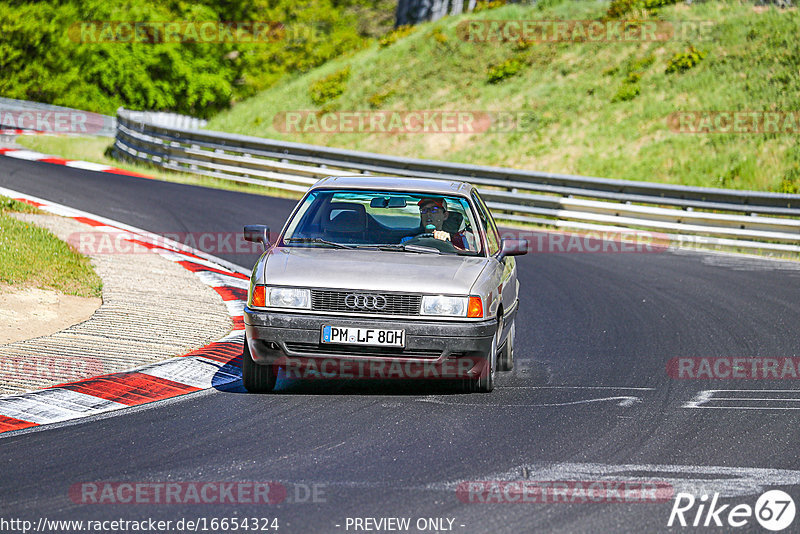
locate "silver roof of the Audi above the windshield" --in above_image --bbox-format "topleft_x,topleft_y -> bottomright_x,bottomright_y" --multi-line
311,174 -> 473,196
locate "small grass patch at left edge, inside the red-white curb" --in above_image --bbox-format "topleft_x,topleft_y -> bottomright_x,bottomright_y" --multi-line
0,197 -> 103,297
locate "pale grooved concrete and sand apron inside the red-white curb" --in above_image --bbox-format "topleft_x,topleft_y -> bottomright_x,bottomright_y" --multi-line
0,213 -> 232,396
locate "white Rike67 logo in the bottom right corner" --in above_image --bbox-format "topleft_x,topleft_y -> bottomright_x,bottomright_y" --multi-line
667,490 -> 795,532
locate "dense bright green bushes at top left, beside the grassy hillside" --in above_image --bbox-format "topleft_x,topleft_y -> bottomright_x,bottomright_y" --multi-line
0,0 -> 376,117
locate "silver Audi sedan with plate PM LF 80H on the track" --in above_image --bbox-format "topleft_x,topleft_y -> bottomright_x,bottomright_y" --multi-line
242,176 -> 528,392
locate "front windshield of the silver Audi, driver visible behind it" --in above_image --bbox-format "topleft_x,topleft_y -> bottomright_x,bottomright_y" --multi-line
281,190 -> 483,256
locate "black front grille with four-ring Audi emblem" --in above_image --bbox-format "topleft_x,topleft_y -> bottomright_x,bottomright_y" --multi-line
311,289 -> 422,316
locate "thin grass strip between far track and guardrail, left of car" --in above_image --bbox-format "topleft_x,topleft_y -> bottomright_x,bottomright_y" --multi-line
16,135 -> 300,199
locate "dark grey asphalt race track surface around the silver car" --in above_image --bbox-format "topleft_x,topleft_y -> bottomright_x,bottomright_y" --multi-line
0,157 -> 800,533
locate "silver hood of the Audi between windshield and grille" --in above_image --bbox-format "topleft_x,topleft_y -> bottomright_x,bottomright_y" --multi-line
264,247 -> 488,295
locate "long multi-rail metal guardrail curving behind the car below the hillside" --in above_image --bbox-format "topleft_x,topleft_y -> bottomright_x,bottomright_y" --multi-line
114,108 -> 800,252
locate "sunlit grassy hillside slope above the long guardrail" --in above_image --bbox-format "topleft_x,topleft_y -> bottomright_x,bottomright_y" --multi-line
209,0 -> 800,192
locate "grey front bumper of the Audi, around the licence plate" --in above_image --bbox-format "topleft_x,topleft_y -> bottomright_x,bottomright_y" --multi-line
244,307 -> 497,378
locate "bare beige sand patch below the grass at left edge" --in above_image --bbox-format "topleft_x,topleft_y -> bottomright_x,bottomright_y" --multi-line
0,284 -> 102,345
